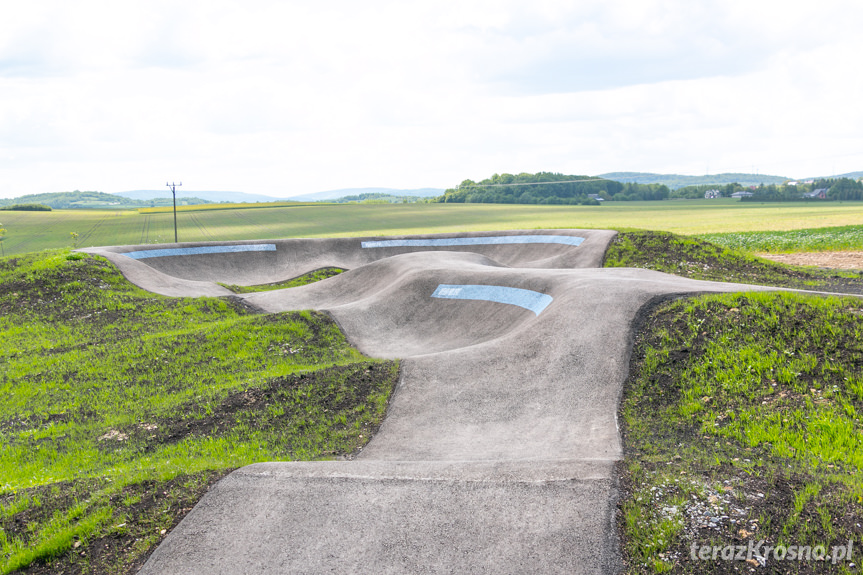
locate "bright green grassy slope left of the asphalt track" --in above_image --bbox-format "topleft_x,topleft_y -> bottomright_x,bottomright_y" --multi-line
0,250 -> 398,573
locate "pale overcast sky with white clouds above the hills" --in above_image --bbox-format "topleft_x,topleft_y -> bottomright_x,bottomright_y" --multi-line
0,0 -> 863,197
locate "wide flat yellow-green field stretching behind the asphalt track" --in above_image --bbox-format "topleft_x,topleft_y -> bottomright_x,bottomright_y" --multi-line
2,200 -> 863,255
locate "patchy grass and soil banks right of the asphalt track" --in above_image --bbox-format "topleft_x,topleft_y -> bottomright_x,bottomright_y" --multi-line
607,233 -> 863,574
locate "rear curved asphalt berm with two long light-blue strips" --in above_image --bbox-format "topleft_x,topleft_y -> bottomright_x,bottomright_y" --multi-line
83,230 -> 614,296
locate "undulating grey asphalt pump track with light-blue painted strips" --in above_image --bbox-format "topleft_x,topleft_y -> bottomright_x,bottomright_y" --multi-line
86,230 -> 771,575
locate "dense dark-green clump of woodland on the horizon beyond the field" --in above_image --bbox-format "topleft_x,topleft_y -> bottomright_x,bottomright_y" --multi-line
434,172 -> 669,205
